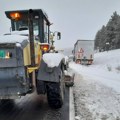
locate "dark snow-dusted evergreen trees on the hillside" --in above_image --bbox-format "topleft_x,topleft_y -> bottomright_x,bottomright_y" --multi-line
95,11 -> 120,51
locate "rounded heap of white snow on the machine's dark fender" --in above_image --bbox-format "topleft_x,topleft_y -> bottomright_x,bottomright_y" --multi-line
43,53 -> 65,68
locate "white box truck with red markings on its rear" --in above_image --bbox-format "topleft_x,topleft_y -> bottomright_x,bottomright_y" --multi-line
73,40 -> 94,65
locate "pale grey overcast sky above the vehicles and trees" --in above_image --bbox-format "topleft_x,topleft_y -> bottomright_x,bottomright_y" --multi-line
0,0 -> 120,48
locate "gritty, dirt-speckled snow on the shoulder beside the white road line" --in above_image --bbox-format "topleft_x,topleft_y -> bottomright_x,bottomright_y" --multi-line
74,75 -> 120,120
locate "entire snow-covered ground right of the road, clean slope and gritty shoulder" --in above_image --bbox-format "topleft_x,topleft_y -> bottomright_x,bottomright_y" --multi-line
69,49 -> 120,120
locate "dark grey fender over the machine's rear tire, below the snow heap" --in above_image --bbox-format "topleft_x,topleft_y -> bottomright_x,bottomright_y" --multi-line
36,59 -> 64,94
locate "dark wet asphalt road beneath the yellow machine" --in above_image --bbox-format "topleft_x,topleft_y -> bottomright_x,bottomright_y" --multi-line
0,88 -> 69,120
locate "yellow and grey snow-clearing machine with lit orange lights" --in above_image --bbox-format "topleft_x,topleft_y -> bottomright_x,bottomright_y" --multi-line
0,9 -> 65,108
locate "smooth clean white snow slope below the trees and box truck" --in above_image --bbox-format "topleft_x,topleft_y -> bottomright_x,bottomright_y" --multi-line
69,49 -> 120,92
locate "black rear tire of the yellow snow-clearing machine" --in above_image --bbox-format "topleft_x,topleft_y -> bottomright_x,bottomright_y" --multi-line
47,83 -> 64,109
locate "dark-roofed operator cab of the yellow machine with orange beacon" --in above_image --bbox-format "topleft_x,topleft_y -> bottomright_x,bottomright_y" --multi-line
5,9 -> 51,43
